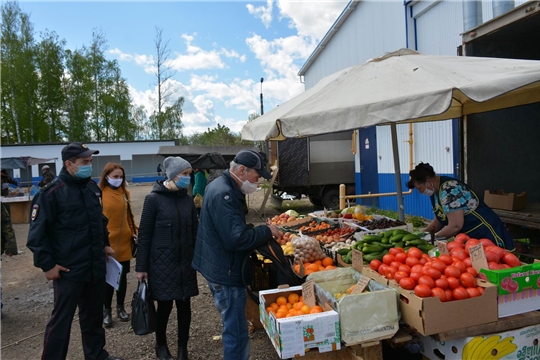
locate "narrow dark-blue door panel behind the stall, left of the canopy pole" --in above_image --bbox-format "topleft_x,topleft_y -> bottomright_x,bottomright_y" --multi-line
359,126 -> 379,206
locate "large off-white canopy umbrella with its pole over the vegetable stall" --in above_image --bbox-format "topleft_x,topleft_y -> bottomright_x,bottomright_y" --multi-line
242,49 -> 540,218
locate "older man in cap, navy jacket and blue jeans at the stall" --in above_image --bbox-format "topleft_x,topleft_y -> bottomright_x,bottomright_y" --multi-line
192,150 -> 279,360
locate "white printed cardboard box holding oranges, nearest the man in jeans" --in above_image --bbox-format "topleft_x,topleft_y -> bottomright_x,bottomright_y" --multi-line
259,286 -> 341,359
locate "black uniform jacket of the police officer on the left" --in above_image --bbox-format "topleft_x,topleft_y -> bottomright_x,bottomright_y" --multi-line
26,169 -> 109,281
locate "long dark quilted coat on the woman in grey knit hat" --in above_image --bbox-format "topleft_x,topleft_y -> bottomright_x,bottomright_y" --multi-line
135,180 -> 199,301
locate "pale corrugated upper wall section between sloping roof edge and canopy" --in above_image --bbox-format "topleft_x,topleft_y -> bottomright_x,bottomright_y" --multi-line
304,1 -> 406,90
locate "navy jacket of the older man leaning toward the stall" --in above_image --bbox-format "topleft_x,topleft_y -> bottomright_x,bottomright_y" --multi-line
193,170 -> 272,287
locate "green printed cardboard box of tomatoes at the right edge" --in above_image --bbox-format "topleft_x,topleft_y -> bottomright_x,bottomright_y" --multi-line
478,262 -> 540,295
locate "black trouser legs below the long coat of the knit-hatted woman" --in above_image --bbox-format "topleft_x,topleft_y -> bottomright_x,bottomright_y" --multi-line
156,298 -> 191,346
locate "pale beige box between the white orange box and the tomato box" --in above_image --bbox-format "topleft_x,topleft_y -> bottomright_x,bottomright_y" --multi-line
308,267 -> 399,346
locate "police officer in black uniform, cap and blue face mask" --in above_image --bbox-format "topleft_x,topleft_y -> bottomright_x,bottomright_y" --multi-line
27,142 -> 121,360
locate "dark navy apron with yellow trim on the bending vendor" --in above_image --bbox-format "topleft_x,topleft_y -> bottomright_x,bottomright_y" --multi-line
430,176 -> 514,250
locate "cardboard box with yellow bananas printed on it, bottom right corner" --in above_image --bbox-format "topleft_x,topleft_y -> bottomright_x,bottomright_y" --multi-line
420,325 -> 540,360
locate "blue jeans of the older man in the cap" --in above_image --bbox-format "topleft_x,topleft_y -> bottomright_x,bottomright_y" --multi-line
208,282 -> 249,360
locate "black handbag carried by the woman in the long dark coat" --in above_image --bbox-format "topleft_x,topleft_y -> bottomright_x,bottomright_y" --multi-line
131,279 -> 157,335
